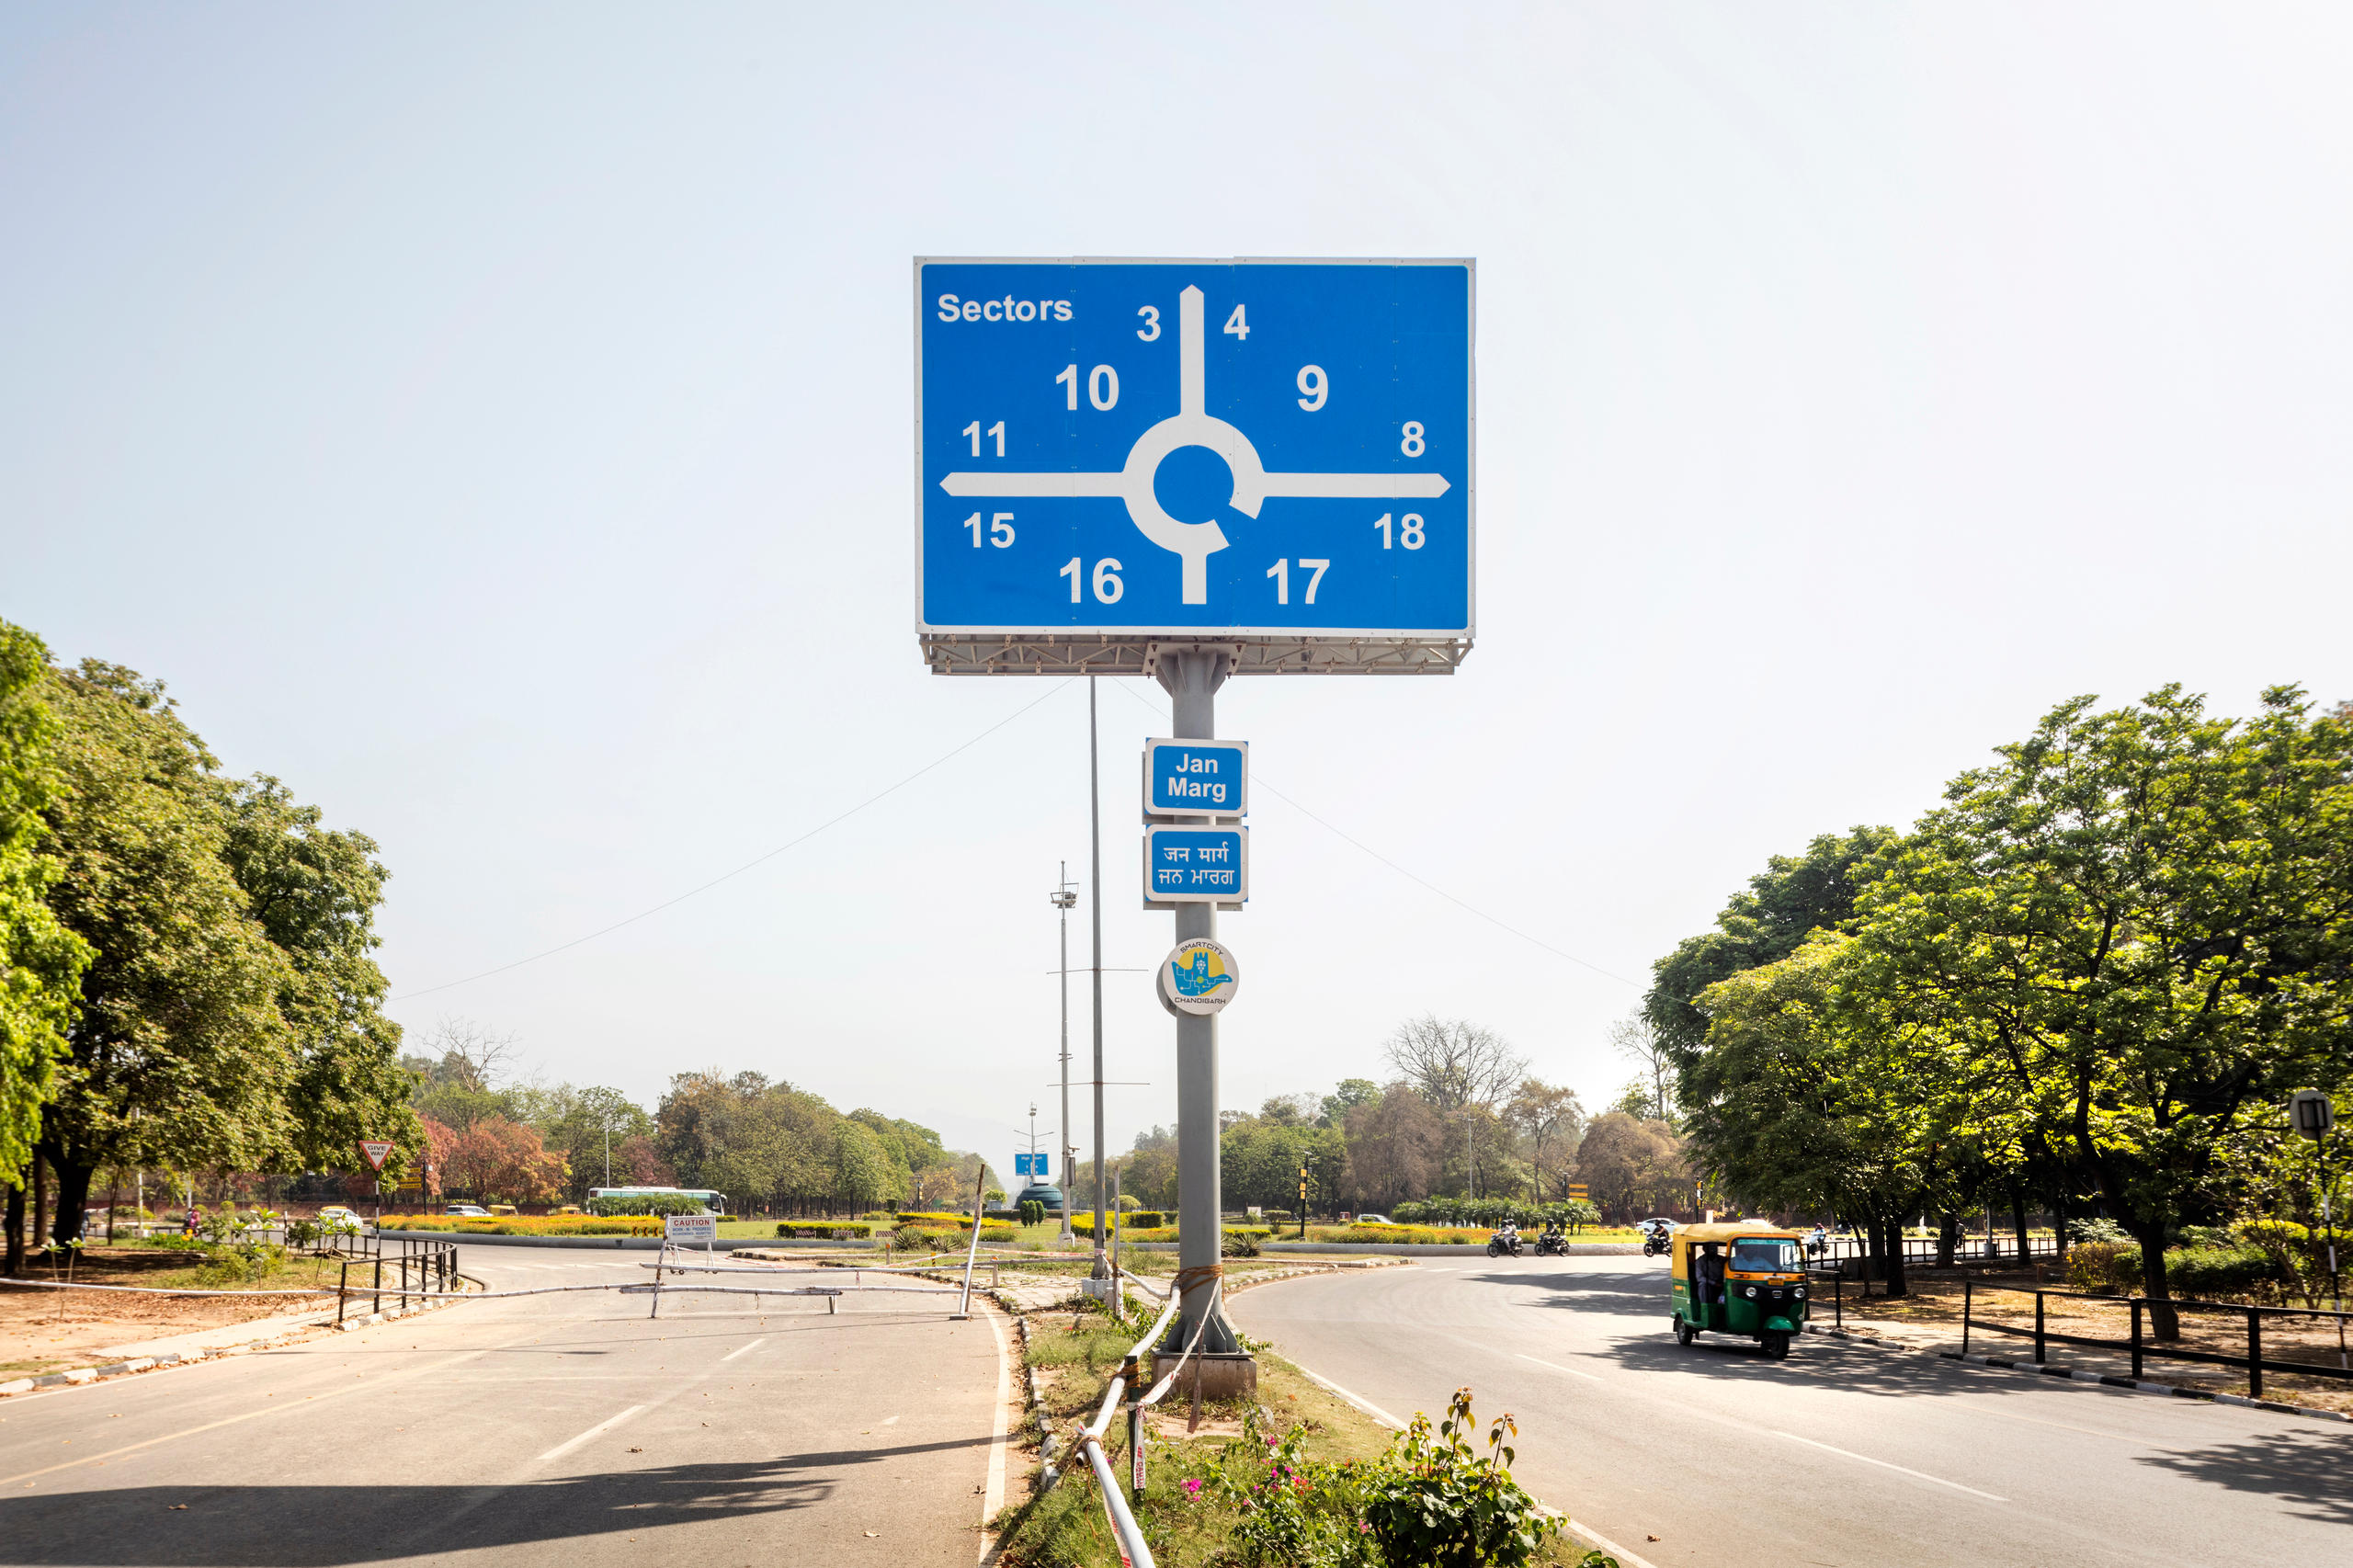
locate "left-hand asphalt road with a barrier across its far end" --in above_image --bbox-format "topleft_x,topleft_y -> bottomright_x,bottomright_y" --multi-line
0,1245 -> 1005,1568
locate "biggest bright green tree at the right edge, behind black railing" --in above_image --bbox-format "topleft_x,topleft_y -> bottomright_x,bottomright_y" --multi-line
1852,687 -> 2353,1337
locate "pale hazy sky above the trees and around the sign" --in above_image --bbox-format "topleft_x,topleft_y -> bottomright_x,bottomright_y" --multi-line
0,3 -> 2353,1168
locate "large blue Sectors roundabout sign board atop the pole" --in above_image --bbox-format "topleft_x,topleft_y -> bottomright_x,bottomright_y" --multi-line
915,261 -> 1473,638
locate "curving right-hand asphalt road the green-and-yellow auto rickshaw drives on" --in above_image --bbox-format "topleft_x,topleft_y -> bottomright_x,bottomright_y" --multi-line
1231,1257 -> 2353,1568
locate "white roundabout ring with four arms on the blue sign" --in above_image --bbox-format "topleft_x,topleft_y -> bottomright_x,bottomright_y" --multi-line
938,285 -> 1447,605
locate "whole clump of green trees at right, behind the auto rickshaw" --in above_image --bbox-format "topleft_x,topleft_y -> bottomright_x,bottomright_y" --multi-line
1644,687 -> 2353,1337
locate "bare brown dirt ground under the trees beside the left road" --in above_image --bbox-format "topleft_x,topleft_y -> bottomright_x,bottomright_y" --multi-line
0,1248 -> 335,1380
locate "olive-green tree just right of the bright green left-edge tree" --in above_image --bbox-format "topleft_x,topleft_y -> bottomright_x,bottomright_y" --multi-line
40,659 -> 299,1244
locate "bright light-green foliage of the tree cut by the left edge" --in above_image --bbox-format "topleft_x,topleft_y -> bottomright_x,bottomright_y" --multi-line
0,621 -> 92,1191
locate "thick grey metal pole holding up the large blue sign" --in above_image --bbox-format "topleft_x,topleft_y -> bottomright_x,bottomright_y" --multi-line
1158,653 -> 1240,1356
